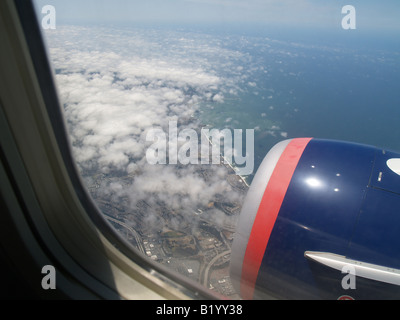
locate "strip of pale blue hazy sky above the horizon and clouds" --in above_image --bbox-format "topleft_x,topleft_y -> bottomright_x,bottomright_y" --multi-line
35,0 -> 400,30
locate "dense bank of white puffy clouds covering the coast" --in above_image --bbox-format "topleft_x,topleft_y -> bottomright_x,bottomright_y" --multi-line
48,27 -> 247,228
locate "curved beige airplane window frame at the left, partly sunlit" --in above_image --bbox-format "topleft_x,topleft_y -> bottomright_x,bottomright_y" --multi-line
0,0 -> 221,299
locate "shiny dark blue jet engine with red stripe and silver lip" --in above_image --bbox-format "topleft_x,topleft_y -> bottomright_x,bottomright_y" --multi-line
231,138 -> 400,299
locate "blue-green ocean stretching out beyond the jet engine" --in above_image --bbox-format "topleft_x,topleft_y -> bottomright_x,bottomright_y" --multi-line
191,25 -> 400,180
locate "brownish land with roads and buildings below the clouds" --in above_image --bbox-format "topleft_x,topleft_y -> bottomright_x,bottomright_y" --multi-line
83,162 -> 248,299
